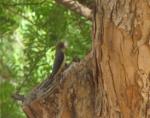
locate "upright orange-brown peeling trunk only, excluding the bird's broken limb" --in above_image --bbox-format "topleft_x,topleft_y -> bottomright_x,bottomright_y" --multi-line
93,0 -> 150,118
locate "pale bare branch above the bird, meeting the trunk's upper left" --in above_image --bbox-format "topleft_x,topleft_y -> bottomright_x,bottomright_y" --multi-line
55,0 -> 92,20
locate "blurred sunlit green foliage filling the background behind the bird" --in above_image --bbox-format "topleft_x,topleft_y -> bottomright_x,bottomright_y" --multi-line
0,0 -> 91,118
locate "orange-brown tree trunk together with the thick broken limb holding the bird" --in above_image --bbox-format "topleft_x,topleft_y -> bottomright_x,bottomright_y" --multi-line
23,0 -> 150,118
